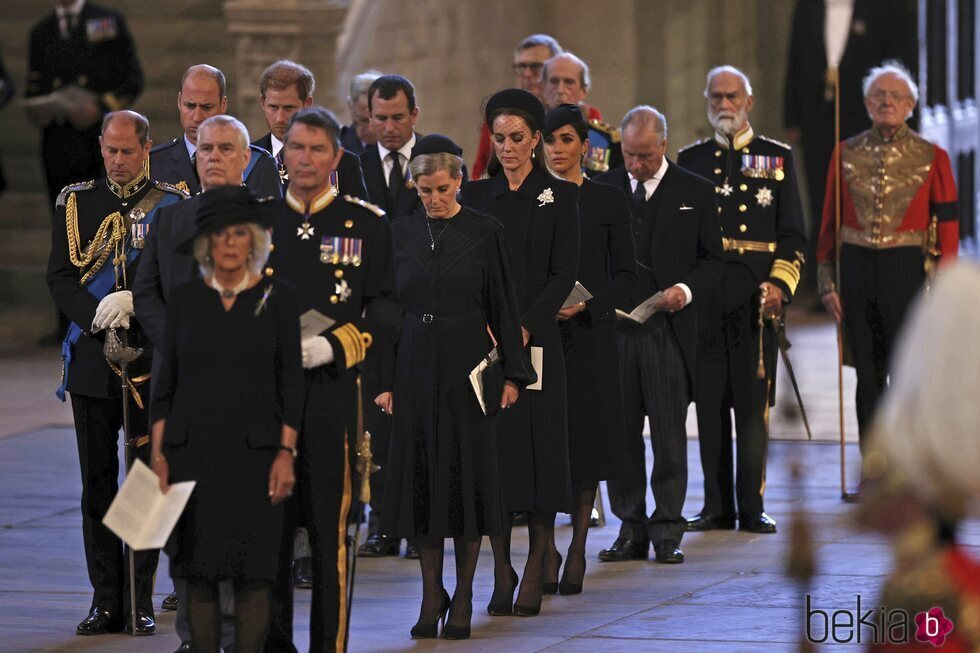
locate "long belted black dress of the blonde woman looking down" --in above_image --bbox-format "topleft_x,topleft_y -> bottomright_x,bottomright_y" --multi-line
381,208 -> 531,539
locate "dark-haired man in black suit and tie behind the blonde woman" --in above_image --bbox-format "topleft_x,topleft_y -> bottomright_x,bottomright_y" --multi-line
361,75 -> 422,220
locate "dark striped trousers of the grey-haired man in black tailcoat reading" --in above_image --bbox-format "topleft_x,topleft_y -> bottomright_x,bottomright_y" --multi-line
608,313 -> 691,543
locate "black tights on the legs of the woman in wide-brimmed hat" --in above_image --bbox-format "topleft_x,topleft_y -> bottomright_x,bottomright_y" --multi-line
187,579 -> 271,653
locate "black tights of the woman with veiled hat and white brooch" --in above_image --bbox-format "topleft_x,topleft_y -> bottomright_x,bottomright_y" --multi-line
490,511 -> 555,606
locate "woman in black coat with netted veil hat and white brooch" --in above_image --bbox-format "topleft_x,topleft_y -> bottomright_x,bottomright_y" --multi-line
462,89 -> 579,616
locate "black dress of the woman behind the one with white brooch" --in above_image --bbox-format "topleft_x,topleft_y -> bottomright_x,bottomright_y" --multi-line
558,179 -> 636,490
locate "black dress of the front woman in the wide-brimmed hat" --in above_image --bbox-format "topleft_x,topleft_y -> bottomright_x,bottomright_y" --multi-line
152,279 -> 303,581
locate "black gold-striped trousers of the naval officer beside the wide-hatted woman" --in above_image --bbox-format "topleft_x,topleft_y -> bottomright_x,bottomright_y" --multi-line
265,366 -> 357,653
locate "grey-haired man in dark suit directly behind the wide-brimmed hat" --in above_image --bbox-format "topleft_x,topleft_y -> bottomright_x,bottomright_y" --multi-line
133,115 -> 254,651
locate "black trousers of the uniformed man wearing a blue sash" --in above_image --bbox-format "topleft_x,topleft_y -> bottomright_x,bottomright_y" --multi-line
71,394 -> 160,617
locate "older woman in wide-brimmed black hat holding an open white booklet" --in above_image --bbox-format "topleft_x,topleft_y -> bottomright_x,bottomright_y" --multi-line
151,186 -> 303,653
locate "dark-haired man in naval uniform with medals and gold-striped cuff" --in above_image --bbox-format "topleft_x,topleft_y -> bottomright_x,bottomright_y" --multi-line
266,107 -> 400,651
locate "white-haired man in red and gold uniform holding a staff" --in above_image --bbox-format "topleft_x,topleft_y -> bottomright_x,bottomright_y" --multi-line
817,61 -> 959,447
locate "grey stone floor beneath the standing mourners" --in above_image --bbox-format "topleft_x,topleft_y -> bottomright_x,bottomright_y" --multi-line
0,316 -> 980,653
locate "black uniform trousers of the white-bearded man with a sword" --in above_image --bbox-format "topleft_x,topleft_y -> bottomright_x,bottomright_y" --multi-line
694,284 -> 776,518
